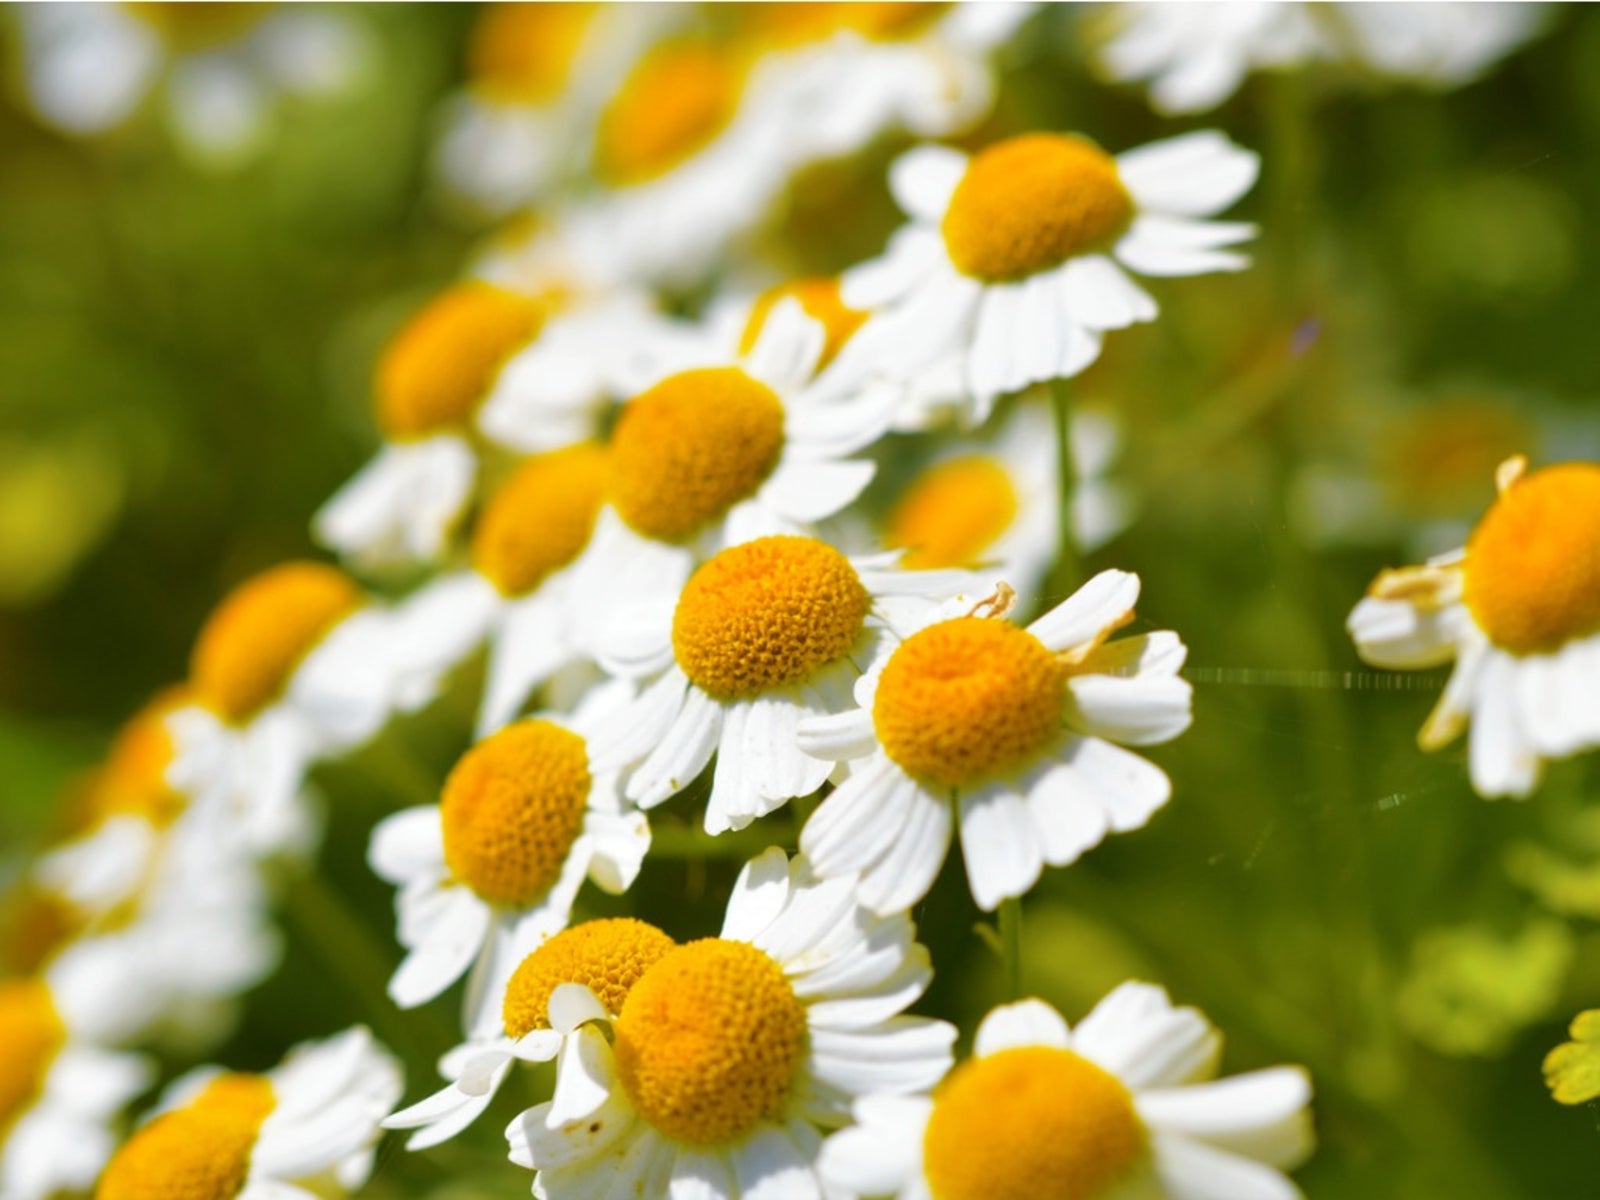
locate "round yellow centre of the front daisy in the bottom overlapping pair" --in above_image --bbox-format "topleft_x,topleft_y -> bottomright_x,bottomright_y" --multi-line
616,938 -> 806,1146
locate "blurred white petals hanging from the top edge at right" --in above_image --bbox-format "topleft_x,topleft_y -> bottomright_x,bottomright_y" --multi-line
1096,3 -> 1546,114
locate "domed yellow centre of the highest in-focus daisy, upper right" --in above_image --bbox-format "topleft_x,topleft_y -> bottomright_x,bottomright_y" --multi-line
942,133 -> 1133,283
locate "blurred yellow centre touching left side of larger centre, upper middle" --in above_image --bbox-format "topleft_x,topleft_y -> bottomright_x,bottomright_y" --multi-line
472,445 -> 605,595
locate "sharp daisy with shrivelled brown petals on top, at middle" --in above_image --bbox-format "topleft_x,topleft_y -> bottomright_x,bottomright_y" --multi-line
798,571 -> 1190,912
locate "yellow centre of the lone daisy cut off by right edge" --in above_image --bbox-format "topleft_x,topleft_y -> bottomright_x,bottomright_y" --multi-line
1466,462 -> 1600,654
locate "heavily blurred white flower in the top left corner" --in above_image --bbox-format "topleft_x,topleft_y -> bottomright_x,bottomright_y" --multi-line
18,3 -> 371,166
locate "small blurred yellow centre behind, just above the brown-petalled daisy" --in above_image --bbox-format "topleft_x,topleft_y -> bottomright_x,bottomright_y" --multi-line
886,454 -> 1018,570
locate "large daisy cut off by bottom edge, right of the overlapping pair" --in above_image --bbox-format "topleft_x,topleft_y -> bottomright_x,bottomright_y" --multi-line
821,984 -> 1312,1200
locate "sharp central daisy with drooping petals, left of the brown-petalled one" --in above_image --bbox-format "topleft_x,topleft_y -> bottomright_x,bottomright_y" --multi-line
598,534 -> 971,834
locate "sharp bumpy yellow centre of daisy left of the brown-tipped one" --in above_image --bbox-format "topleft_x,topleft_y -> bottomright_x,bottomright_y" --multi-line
672,536 -> 870,699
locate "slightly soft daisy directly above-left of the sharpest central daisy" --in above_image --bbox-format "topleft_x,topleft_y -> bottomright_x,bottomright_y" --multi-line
576,299 -> 893,643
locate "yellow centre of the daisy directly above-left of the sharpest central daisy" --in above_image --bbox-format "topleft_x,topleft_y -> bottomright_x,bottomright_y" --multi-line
610,366 -> 784,542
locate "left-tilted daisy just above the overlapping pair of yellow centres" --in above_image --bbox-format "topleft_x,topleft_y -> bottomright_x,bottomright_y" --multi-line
368,685 -> 650,1032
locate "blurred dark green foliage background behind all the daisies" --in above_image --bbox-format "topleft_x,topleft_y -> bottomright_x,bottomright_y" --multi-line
0,5 -> 1600,1200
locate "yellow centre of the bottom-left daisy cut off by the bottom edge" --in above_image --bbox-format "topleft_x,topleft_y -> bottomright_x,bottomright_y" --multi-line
94,1075 -> 277,1200
